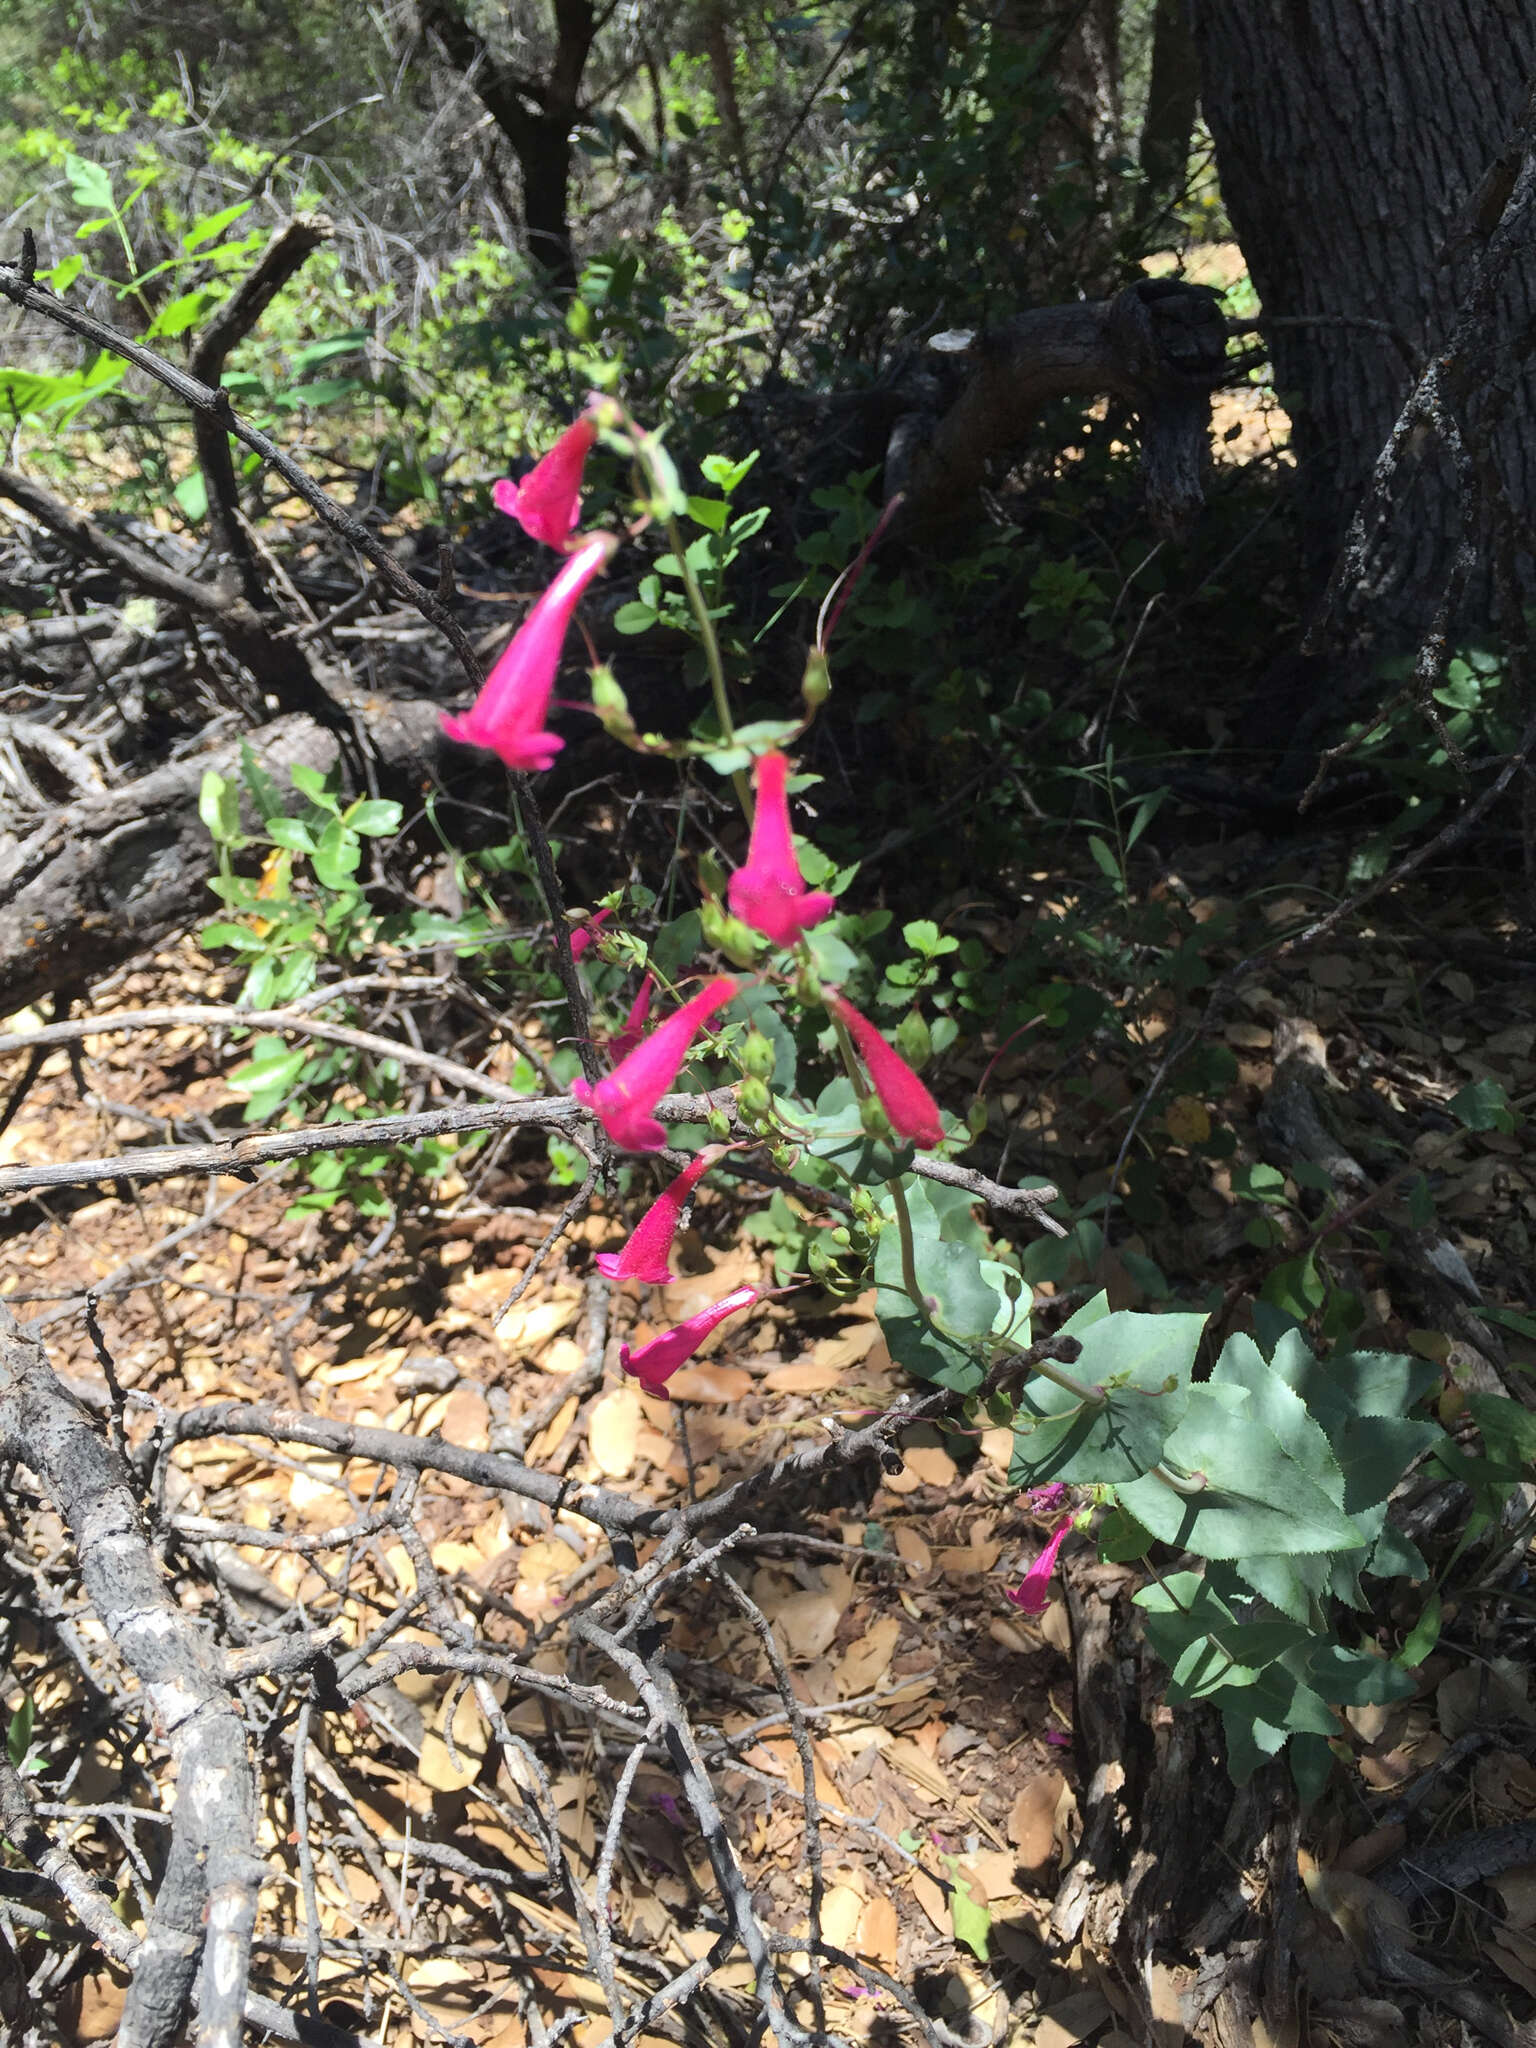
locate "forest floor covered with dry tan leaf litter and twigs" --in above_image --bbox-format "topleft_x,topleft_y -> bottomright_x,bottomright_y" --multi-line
0,790 -> 1536,2048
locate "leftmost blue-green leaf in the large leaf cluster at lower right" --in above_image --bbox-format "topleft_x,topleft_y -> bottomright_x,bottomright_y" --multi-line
1008,1305 -> 1206,1482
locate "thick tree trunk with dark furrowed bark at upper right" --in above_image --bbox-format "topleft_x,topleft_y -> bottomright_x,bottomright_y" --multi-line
1192,0 -> 1536,643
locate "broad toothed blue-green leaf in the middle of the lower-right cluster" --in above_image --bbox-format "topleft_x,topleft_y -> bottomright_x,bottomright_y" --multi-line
1120,1386 -> 1364,1559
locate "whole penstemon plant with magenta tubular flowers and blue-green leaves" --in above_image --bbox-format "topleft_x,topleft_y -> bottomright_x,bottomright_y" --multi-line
327,397 -> 1490,1796
